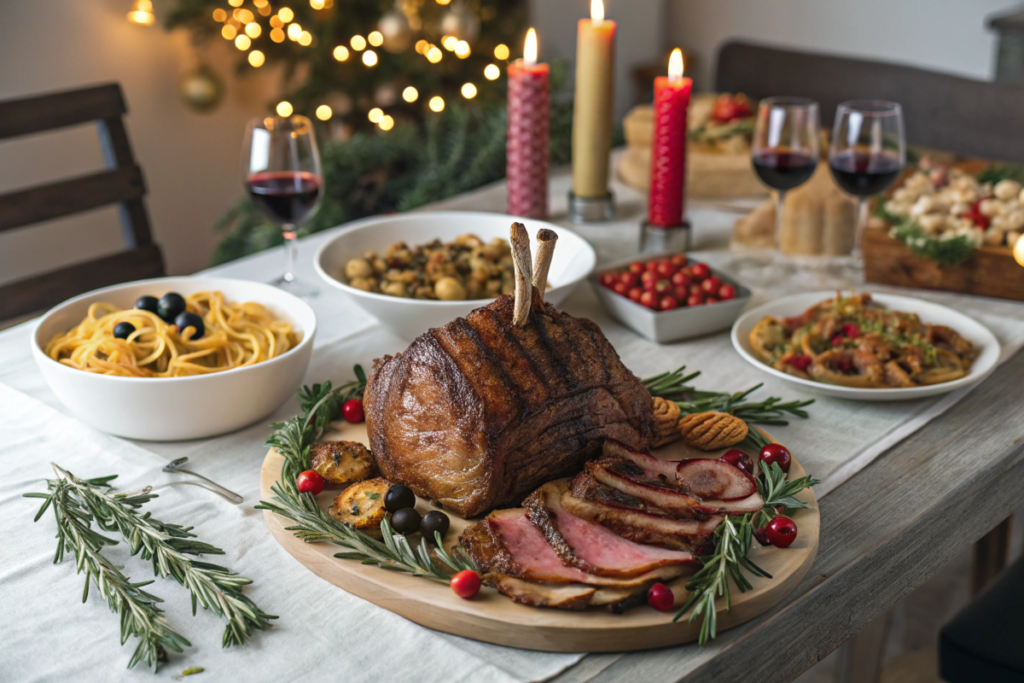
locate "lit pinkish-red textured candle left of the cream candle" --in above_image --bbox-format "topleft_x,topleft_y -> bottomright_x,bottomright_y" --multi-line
505,29 -> 551,218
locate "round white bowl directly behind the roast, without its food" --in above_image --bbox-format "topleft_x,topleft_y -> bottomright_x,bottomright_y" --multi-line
313,211 -> 597,340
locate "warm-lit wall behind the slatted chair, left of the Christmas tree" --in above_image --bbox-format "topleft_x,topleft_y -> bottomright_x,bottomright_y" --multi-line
0,0 -> 273,282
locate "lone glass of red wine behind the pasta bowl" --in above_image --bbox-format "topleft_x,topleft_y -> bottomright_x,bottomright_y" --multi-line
242,116 -> 324,298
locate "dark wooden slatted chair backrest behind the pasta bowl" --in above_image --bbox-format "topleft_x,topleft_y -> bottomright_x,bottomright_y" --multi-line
0,83 -> 164,321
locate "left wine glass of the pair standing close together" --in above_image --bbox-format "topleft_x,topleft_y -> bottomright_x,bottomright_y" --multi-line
751,97 -> 820,247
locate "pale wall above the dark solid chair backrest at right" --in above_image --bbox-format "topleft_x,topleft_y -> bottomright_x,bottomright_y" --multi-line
668,0 -> 1019,89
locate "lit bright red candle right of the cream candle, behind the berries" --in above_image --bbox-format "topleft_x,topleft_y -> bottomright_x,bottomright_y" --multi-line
647,48 -> 693,227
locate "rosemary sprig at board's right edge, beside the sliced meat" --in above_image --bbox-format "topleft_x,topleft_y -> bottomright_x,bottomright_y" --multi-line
672,462 -> 818,645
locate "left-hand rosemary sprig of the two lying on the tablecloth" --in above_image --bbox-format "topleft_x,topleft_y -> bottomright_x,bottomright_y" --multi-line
25,477 -> 191,672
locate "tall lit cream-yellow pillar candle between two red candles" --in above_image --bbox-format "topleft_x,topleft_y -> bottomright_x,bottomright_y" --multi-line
572,0 -> 615,198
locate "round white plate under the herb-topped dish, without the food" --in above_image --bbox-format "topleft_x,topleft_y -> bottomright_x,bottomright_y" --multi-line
732,292 -> 1001,401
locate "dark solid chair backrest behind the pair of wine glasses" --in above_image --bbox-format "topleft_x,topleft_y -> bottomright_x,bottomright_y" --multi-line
715,42 -> 1024,163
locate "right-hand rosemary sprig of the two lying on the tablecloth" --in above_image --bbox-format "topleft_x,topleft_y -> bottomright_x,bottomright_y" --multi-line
53,465 -> 278,647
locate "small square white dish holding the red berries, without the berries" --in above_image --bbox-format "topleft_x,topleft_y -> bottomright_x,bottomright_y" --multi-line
590,253 -> 751,344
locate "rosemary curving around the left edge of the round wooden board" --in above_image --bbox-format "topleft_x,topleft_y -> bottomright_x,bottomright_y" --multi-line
256,366 -> 476,582
